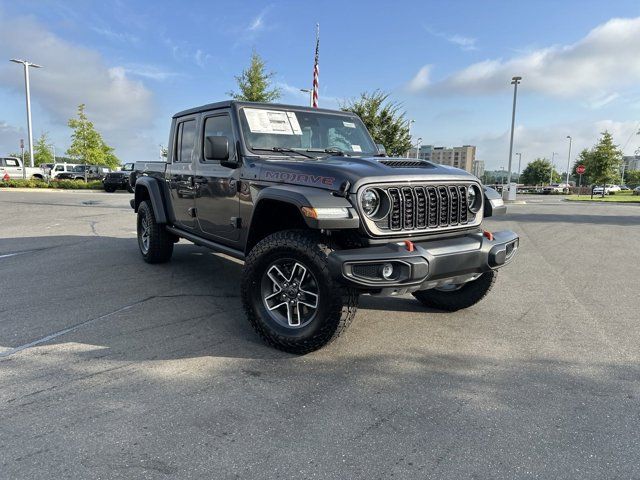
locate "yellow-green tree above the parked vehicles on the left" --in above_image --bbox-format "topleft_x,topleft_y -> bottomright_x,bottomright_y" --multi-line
67,103 -> 120,168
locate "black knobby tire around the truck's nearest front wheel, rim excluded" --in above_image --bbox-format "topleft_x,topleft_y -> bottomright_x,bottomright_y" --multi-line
241,230 -> 358,354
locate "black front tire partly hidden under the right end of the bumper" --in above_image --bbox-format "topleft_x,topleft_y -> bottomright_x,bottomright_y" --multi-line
413,270 -> 498,312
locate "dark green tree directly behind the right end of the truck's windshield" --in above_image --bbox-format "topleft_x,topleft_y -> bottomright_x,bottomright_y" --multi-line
340,90 -> 411,156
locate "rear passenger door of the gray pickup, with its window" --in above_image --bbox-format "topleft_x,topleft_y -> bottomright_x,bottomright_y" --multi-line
167,117 -> 197,229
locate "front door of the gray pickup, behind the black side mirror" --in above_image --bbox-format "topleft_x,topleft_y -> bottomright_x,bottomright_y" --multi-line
195,112 -> 240,240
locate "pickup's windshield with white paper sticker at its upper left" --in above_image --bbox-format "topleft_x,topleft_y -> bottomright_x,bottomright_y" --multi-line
240,107 -> 378,156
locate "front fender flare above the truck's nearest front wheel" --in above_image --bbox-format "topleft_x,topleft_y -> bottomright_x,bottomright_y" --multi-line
250,185 -> 360,229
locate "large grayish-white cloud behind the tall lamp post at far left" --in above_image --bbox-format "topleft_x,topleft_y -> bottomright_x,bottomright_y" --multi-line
0,13 -> 154,161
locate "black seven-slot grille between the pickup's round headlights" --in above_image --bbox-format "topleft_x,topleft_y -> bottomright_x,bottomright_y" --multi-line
375,185 -> 475,231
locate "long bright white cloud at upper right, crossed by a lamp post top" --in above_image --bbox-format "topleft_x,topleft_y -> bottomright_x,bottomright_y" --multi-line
409,17 -> 640,98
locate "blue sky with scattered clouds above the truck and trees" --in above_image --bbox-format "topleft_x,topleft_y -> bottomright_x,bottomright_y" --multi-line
0,0 -> 640,169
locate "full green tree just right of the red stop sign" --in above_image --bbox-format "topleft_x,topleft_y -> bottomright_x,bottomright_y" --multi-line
574,130 -> 623,197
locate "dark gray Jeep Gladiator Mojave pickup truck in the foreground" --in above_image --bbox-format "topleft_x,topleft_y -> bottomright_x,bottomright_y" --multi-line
131,101 -> 518,353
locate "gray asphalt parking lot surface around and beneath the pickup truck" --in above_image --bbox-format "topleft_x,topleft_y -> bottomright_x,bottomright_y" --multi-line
0,190 -> 640,479
